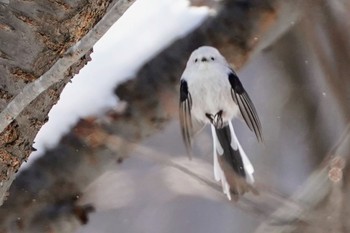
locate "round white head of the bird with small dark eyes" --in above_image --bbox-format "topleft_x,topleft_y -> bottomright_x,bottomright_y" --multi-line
187,46 -> 227,66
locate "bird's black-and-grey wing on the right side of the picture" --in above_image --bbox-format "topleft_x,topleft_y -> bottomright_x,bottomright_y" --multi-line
228,70 -> 263,142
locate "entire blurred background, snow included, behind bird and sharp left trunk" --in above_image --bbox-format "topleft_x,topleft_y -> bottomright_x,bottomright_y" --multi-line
0,0 -> 350,233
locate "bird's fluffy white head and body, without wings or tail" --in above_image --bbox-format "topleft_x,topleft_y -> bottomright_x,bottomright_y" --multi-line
181,46 -> 239,123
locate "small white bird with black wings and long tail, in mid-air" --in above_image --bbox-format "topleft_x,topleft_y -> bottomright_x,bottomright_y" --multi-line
179,46 -> 263,200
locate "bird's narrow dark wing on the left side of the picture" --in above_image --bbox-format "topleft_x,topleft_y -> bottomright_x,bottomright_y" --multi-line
179,79 -> 193,156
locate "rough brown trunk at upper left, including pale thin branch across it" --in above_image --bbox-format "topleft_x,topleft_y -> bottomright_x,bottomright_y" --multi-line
0,0 -> 133,204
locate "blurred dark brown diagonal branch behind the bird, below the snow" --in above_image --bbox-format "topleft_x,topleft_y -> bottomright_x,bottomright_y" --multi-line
0,0 -> 288,232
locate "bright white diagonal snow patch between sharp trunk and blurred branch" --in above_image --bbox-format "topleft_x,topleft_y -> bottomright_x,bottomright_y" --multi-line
22,0 -> 209,168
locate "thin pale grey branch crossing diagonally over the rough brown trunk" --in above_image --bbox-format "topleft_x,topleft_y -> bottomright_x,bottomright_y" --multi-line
0,0 -> 135,132
